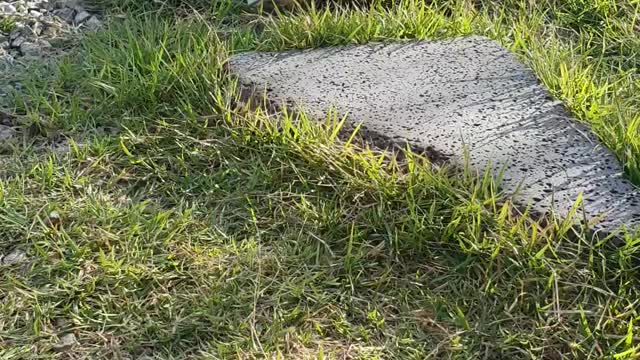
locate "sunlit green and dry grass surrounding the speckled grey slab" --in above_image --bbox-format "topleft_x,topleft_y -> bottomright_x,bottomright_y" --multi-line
0,0 -> 640,359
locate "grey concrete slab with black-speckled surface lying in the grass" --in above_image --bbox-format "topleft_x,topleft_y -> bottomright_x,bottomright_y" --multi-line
229,37 -> 640,232
